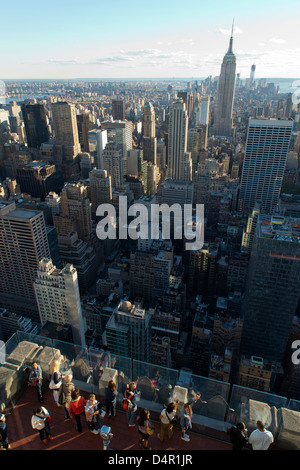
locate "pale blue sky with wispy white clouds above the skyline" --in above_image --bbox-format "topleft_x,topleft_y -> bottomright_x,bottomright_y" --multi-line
0,0 -> 300,79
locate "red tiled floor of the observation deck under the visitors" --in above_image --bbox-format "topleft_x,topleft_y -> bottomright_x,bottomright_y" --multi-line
7,388 -> 231,451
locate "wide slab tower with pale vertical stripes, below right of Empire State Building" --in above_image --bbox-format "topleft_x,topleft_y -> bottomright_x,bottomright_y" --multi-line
239,119 -> 293,214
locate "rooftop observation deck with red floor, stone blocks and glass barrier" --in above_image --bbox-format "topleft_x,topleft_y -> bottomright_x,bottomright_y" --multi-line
0,331 -> 300,452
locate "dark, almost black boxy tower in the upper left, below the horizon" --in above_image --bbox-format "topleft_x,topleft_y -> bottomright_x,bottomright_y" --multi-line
22,104 -> 50,148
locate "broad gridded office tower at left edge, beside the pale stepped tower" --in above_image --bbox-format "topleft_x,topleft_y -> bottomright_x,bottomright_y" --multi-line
0,202 -> 50,322
